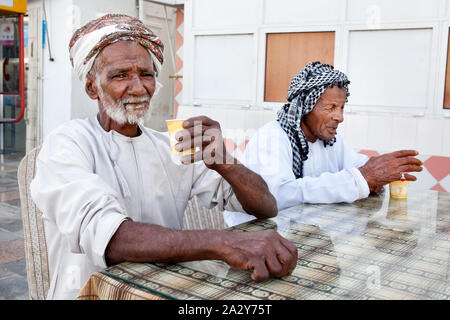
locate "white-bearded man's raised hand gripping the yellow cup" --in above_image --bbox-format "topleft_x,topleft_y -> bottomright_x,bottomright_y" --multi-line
175,116 -> 237,169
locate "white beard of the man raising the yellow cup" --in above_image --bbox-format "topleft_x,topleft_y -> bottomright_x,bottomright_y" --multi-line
98,86 -> 150,125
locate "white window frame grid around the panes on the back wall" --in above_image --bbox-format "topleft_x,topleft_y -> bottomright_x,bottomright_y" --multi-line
182,0 -> 450,118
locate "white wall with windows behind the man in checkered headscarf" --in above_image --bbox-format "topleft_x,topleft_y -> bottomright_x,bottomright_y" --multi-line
178,0 -> 450,156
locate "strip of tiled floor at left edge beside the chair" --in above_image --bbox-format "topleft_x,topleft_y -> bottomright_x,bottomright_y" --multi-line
0,154 -> 29,300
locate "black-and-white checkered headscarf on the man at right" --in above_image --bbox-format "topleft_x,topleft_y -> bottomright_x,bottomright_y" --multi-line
277,61 -> 350,179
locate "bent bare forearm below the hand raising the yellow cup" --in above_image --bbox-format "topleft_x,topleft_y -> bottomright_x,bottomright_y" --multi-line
214,164 -> 278,218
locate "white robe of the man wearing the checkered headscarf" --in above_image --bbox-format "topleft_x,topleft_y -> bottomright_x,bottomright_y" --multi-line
225,121 -> 370,225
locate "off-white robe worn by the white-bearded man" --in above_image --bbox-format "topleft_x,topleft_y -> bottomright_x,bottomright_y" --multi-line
30,118 -> 243,299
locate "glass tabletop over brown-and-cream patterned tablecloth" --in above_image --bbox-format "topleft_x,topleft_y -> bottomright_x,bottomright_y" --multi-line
103,189 -> 450,300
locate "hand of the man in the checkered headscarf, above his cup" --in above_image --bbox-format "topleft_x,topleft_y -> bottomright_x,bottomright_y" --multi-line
359,150 -> 422,193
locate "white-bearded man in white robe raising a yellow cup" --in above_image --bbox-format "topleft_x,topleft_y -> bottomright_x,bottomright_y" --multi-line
31,15 -> 297,299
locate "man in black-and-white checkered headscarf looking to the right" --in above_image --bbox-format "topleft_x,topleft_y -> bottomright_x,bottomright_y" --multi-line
225,61 -> 422,225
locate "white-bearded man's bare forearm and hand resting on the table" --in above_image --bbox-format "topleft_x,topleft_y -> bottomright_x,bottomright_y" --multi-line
105,220 -> 298,281
